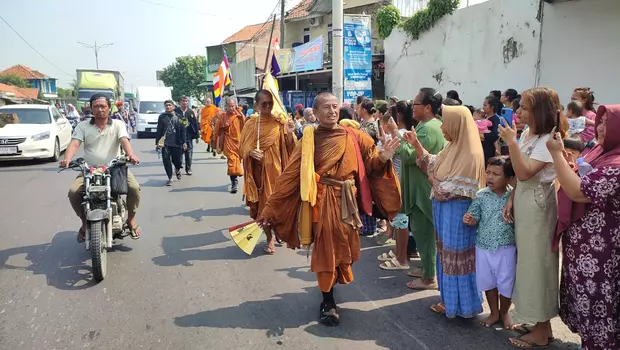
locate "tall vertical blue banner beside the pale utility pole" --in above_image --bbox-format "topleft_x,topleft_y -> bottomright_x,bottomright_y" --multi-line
343,15 -> 372,104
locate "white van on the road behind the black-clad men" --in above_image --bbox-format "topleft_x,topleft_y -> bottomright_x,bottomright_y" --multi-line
136,86 -> 172,138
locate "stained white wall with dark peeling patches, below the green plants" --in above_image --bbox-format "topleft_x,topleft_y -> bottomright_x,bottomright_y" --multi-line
385,0 -> 540,106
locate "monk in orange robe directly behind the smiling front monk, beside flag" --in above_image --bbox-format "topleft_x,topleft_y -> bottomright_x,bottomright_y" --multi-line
240,90 -> 296,254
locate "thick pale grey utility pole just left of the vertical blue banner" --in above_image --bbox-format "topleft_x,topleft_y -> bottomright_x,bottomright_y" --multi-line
332,0 -> 344,102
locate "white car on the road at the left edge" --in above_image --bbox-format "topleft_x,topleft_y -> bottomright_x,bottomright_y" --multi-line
0,105 -> 72,161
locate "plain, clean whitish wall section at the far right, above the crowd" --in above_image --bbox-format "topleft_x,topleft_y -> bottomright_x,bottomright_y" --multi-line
540,0 -> 620,104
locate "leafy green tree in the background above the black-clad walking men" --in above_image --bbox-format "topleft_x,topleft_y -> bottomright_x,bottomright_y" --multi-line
161,56 -> 207,102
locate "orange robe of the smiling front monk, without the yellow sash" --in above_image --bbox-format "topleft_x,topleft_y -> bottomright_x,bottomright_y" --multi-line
261,126 -> 401,292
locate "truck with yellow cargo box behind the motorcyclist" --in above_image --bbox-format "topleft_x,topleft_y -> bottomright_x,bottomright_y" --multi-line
76,69 -> 125,113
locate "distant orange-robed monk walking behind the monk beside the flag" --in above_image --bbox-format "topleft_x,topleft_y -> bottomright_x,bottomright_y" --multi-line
213,97 -> 245,193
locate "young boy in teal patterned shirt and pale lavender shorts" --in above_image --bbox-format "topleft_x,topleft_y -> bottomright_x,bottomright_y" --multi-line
463,156 -> 517,329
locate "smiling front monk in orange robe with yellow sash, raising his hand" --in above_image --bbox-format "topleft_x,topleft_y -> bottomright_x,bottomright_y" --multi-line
257,93 -> 401,326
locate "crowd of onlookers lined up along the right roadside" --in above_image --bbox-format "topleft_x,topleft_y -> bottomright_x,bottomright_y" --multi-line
294,87 -> 620,349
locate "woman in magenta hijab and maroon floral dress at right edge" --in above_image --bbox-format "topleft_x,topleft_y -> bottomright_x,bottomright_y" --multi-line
547,105 -> 620,349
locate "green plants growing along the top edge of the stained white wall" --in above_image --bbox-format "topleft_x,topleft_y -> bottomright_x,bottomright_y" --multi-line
377,0 -> 460,40
